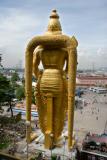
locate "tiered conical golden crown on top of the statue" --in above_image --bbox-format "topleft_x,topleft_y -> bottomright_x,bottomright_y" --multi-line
45,10 -> 62,35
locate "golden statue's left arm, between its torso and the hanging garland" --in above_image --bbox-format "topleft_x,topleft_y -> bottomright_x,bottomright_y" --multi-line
33,52 -> 40,79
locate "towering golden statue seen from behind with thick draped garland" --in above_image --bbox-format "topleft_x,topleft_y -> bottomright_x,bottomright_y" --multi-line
25,10 -> 78,149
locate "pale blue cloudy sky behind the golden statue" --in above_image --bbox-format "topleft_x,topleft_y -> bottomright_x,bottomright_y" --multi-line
0,0 -> 107,68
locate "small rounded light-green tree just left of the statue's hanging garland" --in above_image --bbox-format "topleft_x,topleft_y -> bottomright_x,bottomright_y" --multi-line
16,86 -> 25,100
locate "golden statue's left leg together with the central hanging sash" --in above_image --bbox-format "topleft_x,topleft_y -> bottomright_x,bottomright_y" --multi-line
35,84 -> 53,149
